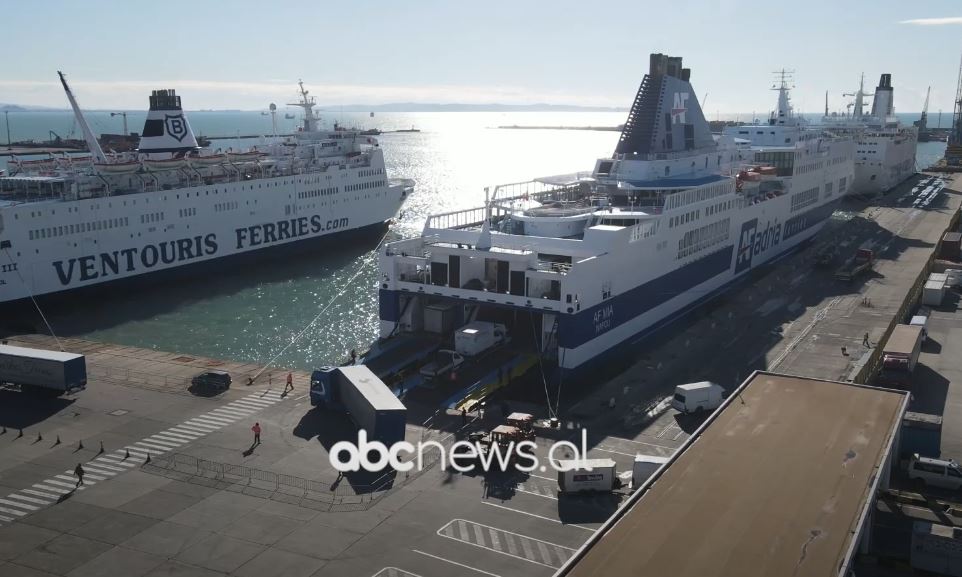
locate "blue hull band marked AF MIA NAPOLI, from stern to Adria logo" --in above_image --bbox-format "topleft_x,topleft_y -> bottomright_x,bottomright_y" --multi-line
558,245 -> 735,349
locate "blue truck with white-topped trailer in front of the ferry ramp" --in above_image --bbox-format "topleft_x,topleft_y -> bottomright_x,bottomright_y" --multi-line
311,365 -> 407,447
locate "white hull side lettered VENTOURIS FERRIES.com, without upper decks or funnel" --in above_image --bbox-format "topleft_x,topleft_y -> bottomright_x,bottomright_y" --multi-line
0,165 -> 405,303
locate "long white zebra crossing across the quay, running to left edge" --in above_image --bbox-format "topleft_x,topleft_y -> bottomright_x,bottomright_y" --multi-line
0,391 -> 286,528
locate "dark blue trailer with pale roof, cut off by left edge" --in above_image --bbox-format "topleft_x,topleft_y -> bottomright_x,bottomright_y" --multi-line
0,345 -> 87,397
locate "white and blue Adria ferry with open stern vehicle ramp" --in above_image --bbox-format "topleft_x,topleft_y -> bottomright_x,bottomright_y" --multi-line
379,54 -> 855,381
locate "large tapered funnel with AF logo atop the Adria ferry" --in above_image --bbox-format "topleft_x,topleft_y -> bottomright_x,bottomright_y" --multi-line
615,54 -> 715,155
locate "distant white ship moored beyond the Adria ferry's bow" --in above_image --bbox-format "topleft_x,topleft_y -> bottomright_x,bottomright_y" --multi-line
822,74 -> 919,195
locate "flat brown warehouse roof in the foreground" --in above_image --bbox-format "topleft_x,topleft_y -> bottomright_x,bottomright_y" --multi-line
558,373 -> 907,577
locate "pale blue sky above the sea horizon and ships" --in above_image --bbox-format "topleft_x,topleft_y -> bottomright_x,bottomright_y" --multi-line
0,0 -> 962,117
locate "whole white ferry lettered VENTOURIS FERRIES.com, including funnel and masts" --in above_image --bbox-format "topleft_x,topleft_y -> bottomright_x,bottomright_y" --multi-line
0,74 -> 412,303
